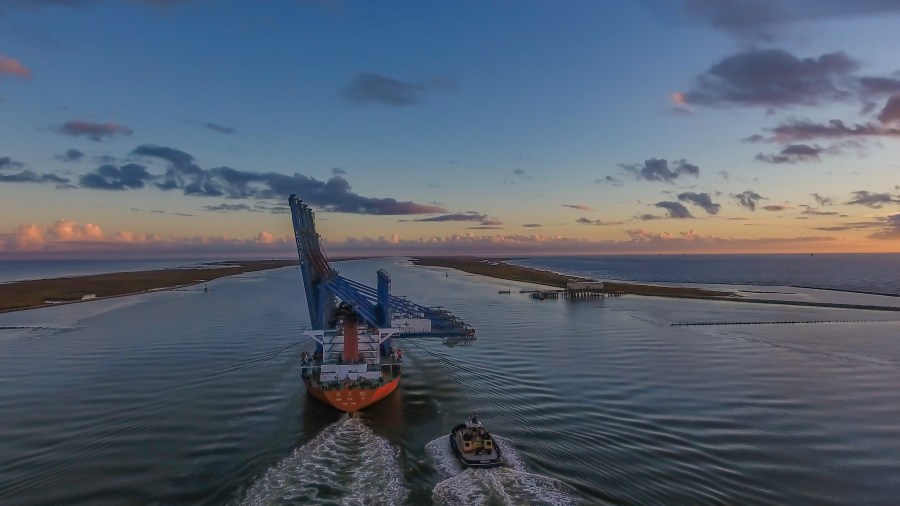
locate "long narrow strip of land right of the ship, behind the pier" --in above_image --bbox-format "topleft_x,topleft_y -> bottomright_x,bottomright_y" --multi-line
410,257 -> 900,311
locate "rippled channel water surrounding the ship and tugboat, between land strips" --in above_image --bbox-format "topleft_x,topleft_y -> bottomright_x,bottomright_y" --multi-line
0,260 -> 900,505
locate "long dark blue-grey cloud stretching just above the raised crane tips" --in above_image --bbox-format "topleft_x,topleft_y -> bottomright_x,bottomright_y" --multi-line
125,145 -> 446,215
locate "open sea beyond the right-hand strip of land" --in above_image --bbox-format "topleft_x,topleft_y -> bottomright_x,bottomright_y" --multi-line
510,253 -> 900,295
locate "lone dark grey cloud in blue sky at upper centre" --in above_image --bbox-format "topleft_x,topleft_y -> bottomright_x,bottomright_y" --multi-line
342,72 -> 456,107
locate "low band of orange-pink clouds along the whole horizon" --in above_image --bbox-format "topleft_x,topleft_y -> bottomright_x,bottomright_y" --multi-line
0,219 -> 900,258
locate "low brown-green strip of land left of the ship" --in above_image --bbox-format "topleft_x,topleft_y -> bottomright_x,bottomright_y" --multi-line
0,260 -> 299,313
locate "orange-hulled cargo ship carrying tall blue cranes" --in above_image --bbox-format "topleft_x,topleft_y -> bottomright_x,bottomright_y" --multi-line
288,195 -> 475,411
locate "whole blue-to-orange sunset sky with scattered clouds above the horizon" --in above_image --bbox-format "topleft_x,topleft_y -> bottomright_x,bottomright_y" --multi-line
0,0 -> 900,259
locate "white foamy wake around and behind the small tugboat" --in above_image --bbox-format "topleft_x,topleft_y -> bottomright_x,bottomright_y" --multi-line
425,435 -> 578,506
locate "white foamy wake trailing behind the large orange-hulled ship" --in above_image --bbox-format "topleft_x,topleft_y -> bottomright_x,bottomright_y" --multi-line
241,417 -> 409,506
